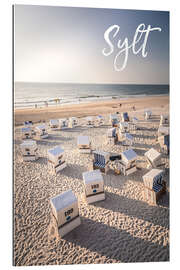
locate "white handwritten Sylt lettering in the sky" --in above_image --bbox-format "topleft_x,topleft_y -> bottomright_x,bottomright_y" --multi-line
102,23 -> 161,71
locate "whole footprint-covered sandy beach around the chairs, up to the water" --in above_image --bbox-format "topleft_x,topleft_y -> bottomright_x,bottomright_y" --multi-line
13,96 -> 169,266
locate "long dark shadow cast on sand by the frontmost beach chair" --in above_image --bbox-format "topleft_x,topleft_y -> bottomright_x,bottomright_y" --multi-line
63,216 -> 169,264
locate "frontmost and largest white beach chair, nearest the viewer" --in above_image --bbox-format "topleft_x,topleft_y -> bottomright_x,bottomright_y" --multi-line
50,190 -> 81,237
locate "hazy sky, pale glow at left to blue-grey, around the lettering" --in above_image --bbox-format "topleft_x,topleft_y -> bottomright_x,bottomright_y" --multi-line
14,5 -> 169,84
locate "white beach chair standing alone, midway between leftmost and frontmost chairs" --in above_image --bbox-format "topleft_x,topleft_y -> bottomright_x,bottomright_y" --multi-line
48,146 -> 66,174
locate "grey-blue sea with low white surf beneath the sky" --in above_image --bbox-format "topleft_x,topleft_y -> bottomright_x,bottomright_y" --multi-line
14,82 -> 169,108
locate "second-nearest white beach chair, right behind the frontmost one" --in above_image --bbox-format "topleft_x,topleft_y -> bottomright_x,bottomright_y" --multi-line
83,170 -> 105,203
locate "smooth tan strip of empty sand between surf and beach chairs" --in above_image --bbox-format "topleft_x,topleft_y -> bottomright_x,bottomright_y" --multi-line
14,95 -> 169,126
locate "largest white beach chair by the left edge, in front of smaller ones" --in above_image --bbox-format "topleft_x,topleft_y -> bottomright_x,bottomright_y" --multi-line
20,140 -> 39,161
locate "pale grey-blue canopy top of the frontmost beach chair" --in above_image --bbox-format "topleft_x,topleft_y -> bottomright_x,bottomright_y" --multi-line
50,189 -> 77,212
